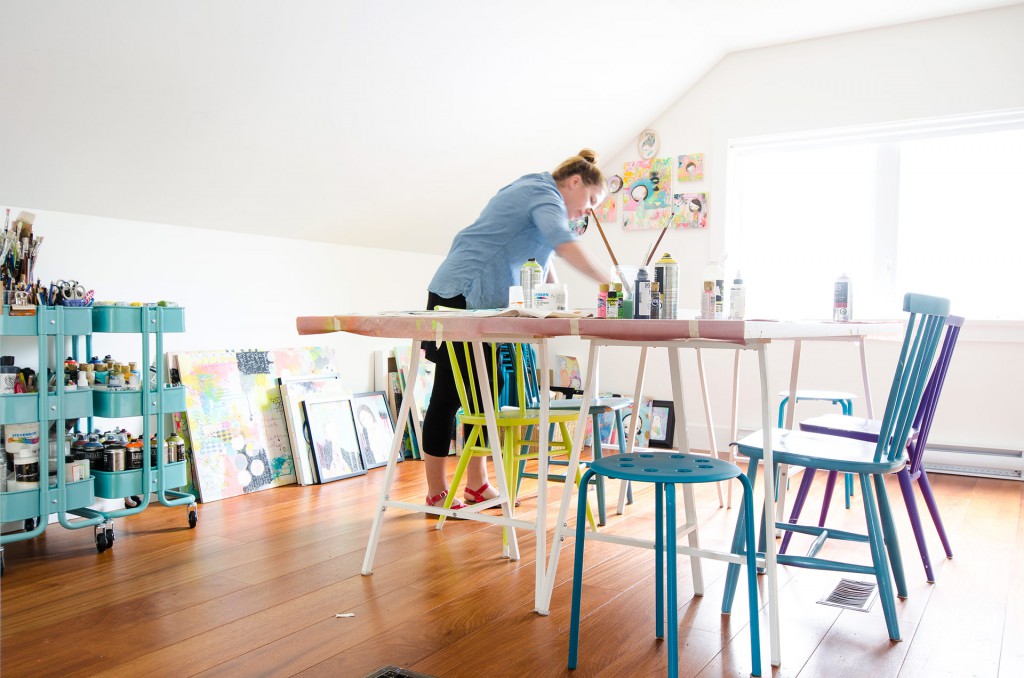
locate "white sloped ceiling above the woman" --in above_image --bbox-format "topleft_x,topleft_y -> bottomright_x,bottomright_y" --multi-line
0,0 -> 1017,253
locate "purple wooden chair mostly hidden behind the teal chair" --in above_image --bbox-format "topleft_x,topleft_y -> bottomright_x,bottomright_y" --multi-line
779,315 -> 964,584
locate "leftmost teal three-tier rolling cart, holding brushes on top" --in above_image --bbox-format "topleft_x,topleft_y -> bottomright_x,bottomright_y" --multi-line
0,306 -> 106,573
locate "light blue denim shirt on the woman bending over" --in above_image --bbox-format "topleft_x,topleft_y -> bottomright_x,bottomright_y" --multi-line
429,172 -> 579,308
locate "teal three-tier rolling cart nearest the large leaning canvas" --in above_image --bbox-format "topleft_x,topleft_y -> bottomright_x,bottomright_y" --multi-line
80,306 -> 199,551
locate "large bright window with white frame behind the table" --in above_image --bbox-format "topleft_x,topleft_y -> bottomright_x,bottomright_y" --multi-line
727,112 -> 1024,321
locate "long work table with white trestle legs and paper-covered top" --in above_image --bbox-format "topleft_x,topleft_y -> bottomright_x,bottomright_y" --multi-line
296,311 -> 901,666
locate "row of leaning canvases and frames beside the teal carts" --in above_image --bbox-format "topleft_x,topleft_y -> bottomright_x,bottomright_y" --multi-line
169,346 -> 394,502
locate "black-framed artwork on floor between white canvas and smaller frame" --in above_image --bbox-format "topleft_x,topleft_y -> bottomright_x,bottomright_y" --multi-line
302,395 -> 367,482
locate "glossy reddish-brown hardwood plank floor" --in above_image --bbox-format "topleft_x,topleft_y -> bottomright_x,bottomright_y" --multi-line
0,461 -> 1024,678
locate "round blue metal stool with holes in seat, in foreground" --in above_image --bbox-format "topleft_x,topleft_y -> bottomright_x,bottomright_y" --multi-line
568,453 -> 761,677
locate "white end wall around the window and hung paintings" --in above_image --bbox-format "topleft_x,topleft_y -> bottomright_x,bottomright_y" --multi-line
561,6 -> 1024,450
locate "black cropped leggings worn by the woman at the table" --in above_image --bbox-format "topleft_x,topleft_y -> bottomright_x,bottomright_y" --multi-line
422,292 -> 502,457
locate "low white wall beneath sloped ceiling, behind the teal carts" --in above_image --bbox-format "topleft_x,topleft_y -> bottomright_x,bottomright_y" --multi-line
0,206 -> 440,392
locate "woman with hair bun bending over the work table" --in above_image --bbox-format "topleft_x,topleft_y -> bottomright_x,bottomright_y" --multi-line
423,149 -> 607,516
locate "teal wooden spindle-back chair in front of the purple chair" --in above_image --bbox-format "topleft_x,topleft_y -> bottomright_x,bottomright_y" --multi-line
722,294 -> 949,640
